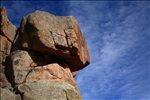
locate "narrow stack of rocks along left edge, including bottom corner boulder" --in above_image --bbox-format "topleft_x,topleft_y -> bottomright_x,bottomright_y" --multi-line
0,8 -> 17,100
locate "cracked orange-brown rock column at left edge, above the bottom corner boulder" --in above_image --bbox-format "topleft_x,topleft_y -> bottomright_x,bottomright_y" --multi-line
0,8 -> 16,88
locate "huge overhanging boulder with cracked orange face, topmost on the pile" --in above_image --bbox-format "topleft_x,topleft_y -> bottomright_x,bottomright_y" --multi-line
13,11 -> 90,71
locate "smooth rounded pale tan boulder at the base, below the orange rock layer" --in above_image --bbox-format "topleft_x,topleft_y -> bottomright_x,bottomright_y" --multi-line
18,81 -> 81,100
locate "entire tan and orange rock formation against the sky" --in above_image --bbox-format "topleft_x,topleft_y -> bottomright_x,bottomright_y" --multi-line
0,8 -> 90,100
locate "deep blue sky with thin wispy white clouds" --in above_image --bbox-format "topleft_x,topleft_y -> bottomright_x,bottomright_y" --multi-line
1,1 -> 150,100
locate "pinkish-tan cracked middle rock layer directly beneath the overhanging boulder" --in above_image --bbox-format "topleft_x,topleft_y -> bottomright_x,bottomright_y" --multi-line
8,50 -> 76,87
